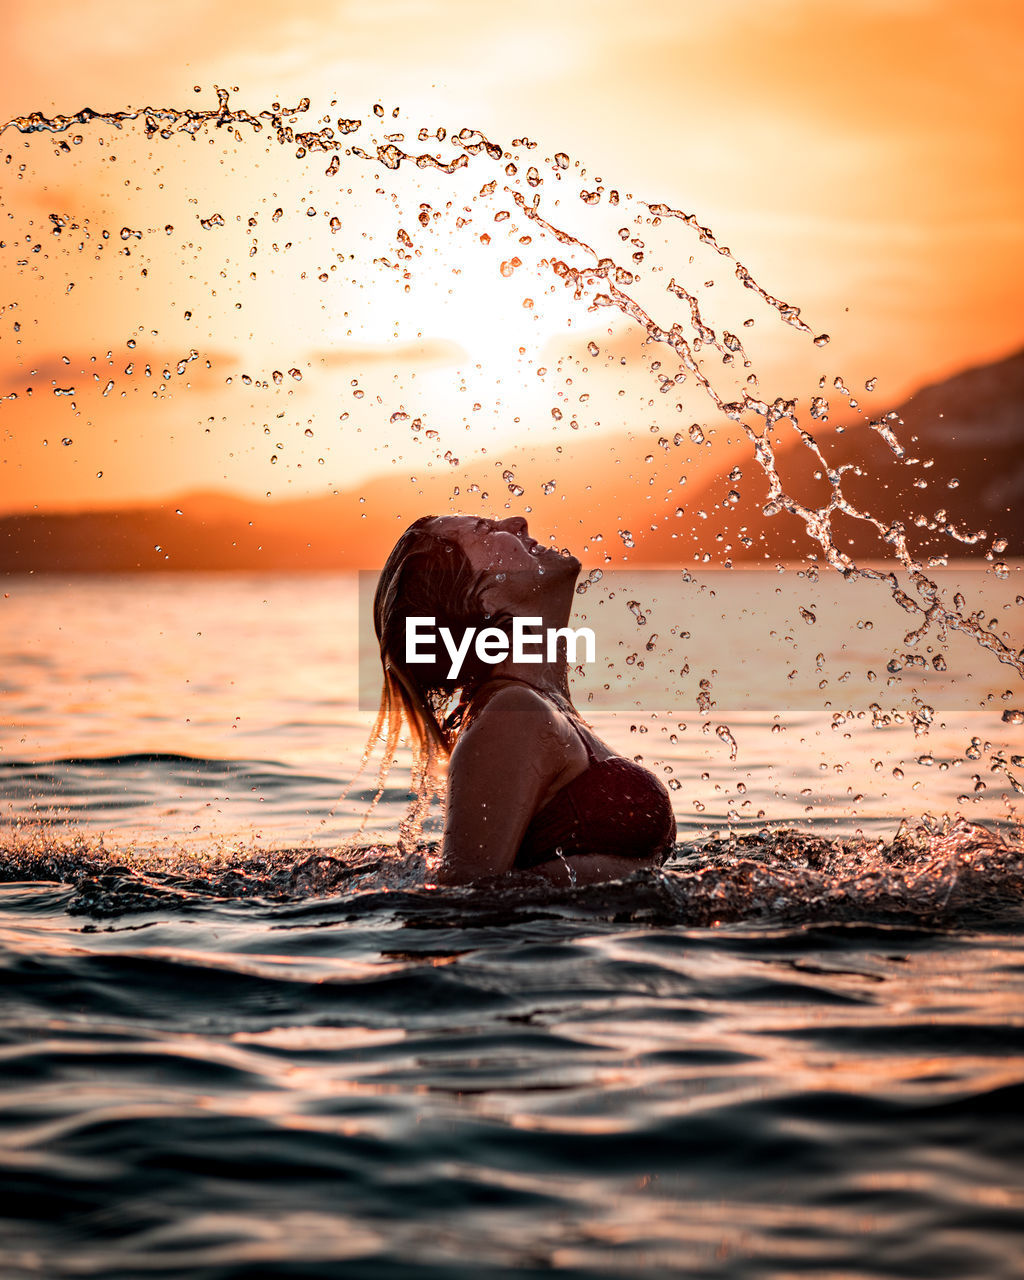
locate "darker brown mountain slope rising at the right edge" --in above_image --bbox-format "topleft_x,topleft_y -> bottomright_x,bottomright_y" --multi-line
634,351 -> 1024,561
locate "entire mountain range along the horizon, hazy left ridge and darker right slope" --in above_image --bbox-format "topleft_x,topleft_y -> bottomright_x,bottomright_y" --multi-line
0,351 -> 1024,573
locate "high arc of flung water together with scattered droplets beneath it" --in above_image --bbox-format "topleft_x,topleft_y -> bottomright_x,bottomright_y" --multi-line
0,88 -> 1024,819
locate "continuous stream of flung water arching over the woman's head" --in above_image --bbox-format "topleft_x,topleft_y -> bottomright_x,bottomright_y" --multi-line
0,88 -> 1024,629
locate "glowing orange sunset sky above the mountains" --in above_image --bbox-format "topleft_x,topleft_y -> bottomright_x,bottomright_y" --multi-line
0,0 -> 1024,511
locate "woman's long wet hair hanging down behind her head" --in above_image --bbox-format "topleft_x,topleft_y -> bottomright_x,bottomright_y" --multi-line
367,516 -> 506,823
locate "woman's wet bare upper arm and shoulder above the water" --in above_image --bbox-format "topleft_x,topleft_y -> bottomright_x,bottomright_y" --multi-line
438,685 -> 582,884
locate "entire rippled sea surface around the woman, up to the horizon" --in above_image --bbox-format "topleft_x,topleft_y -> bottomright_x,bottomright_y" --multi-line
0,562 -> 1024,1280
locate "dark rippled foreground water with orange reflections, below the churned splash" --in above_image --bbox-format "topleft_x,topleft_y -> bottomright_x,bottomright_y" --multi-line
0,884 -> 1024,1280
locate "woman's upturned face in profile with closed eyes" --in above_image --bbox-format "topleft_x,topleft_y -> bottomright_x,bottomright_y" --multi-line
431,516 -> 580,598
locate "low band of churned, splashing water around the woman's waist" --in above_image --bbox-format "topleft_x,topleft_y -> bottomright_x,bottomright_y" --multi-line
0,817 -> 1024,928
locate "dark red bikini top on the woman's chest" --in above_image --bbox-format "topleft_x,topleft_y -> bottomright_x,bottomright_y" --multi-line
512,701 -> 676,870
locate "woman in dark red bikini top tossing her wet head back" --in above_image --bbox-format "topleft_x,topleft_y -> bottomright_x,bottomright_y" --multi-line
374,516 -> 676,884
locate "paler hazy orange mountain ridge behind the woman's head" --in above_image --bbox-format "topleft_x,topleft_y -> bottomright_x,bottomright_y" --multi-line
0,435 -> 742,572
